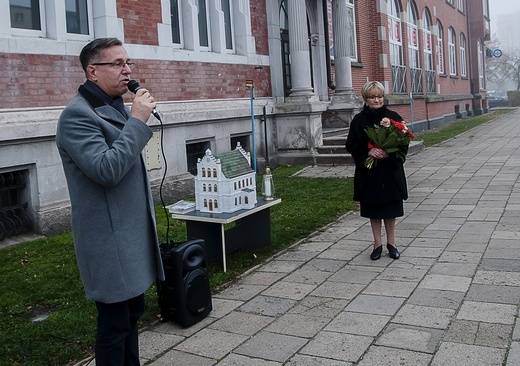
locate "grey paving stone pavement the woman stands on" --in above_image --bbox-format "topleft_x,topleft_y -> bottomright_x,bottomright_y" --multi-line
79,110 -> 520,366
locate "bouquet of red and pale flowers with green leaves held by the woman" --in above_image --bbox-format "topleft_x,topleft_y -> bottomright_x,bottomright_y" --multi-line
365,117 -> 415,169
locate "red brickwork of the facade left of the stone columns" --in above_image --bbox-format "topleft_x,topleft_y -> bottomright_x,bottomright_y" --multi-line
0,0 -> 271,109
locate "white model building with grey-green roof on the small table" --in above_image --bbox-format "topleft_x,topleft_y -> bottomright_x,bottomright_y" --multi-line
195,143 -> 256,213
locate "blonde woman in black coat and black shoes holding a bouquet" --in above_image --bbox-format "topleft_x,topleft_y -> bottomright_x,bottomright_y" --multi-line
346,81 -> 408,260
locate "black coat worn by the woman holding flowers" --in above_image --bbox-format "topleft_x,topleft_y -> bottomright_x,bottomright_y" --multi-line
345,105 -> 408,204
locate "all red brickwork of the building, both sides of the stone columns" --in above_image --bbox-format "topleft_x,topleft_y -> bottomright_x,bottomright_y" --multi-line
0,0 -> 485,120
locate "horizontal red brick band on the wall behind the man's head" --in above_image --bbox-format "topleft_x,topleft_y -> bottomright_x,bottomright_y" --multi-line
0,54 -> 271,108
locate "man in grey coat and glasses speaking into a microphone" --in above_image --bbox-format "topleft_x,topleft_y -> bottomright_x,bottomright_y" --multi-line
56,38 -> 164,366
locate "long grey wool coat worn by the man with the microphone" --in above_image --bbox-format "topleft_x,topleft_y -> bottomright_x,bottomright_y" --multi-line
56,86 -> 164,303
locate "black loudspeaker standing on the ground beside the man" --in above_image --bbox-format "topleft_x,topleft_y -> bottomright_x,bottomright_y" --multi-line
157,239 -> 213,327
